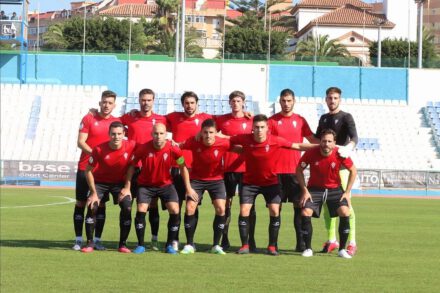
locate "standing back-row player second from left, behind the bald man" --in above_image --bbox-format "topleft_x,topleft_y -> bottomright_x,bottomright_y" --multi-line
121,89 -> 166,251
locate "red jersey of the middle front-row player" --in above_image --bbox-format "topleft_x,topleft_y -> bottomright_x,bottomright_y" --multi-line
182,137 -> 230,181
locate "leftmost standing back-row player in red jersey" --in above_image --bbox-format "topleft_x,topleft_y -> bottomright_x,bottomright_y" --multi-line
72,91 -> 119,250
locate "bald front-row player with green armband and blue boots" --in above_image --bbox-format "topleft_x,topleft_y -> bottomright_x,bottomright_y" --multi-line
124,123 -> 194,254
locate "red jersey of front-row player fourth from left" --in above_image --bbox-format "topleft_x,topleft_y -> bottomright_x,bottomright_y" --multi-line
231,134 -> 292,186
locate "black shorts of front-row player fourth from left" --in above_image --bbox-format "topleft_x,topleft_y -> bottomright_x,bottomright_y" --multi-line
239,184 -> 281,205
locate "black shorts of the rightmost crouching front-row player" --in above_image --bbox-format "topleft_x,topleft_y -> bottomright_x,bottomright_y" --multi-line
304,187 -> 348,218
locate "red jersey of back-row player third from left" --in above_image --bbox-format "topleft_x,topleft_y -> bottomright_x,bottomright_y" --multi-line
165,112 -> 212,168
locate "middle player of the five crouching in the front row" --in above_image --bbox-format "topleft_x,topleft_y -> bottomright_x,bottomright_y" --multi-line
180,119 -> 230,255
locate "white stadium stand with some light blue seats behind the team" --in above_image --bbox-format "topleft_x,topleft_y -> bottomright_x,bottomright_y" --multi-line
1,84 -> 440,170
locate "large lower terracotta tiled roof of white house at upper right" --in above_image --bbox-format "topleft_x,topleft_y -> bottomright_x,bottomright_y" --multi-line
296,4 -> 395,37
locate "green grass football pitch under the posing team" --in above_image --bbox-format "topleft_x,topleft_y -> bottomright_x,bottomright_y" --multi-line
0,188 -> 440,292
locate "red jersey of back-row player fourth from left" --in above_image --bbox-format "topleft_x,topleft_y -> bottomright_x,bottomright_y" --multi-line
215,114 -> 252,172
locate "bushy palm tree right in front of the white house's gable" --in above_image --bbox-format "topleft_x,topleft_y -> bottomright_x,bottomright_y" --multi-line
295,35 -> 350,59
